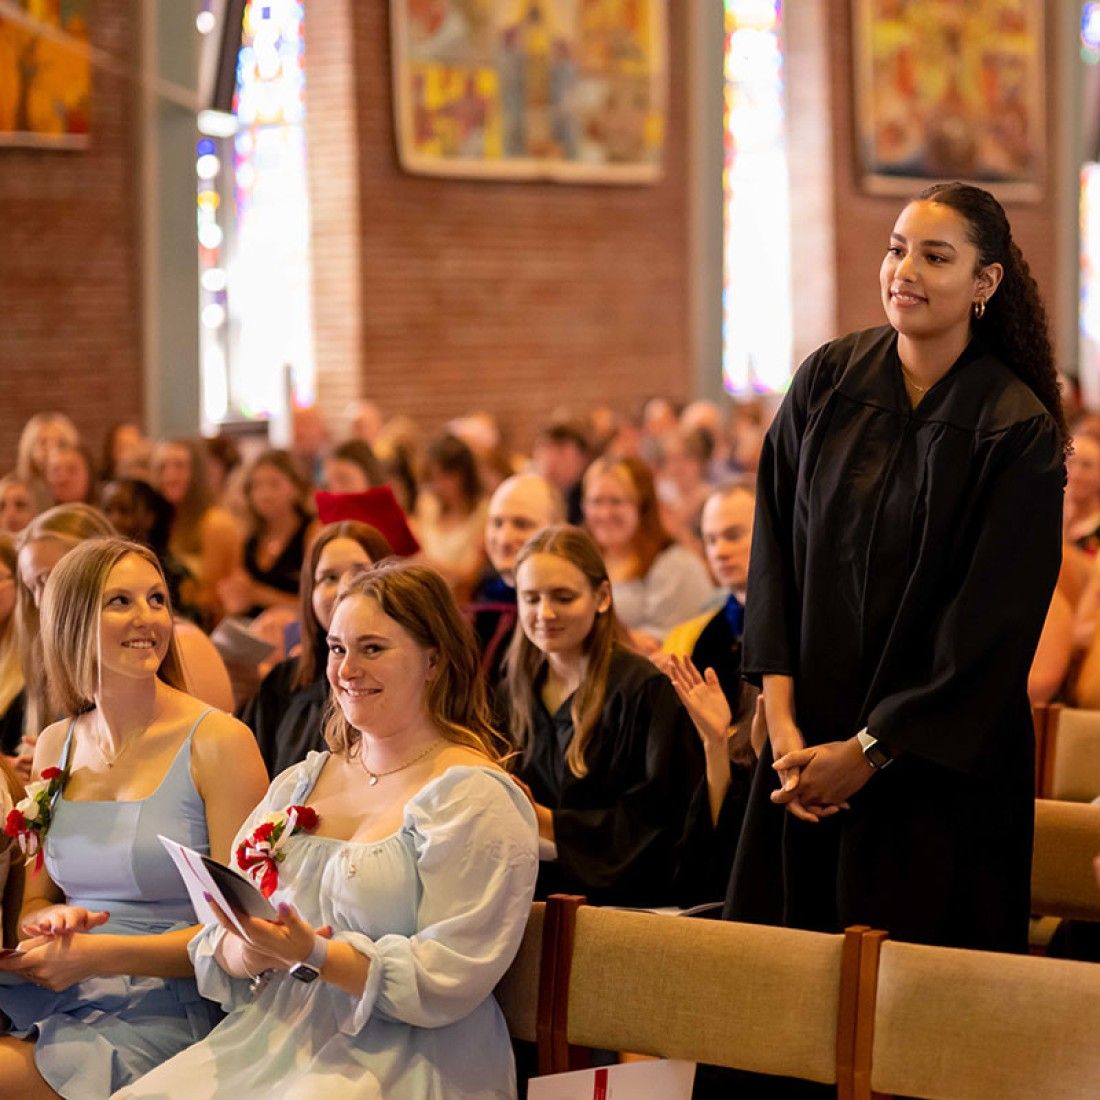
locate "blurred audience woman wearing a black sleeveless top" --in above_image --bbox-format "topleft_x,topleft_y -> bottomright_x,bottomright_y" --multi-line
218,450 -> 317,618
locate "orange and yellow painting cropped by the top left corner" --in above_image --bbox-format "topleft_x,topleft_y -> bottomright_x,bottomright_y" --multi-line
0,0 -> 91,149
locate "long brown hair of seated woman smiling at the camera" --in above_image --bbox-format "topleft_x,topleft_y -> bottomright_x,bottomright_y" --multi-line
325,561 -> 504,761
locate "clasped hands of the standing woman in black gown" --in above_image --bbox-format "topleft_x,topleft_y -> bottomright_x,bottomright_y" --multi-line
768,723 -> 875,823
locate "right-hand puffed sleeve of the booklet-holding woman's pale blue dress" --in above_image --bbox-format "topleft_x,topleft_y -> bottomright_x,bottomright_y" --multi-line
330,768 -> 538,1035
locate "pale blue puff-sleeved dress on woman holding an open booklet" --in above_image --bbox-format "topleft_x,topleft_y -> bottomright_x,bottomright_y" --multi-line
118,752 -> 538,1100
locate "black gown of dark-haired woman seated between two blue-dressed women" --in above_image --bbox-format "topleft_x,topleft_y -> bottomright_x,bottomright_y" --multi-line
240,657 -> 329,779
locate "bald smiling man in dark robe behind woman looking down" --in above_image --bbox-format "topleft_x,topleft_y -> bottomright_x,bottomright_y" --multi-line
466,474 -> 564,692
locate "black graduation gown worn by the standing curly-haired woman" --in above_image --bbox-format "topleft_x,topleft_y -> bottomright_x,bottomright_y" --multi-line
726,328 -> 1065,950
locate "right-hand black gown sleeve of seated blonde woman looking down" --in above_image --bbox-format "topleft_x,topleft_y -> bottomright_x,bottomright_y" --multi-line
553,677 -> 705,905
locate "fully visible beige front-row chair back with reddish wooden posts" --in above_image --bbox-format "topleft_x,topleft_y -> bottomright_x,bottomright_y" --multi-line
550,899 -> 860,1098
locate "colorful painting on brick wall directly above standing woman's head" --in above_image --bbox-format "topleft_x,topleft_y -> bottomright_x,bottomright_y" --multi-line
854,0 -> 1046,200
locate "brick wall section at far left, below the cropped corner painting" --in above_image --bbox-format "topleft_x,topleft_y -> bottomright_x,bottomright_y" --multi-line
0,0 -> 142,473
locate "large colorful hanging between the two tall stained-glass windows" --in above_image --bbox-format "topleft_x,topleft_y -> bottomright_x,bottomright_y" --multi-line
391,0 -> 668,184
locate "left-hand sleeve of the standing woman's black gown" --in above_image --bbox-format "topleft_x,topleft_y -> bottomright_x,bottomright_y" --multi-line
741,349 -> 825,686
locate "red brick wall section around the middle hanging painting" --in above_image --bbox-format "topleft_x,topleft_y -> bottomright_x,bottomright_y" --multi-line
306,0 -> 691,444
